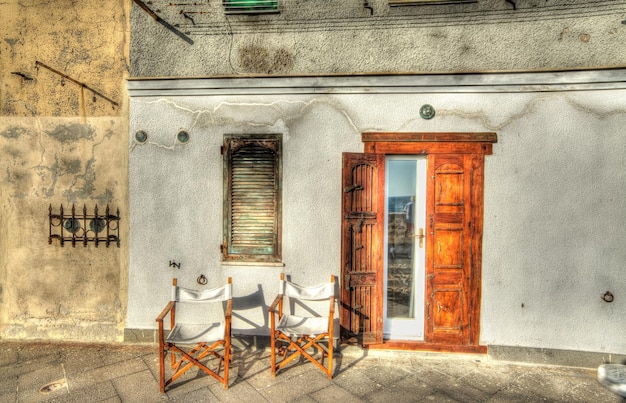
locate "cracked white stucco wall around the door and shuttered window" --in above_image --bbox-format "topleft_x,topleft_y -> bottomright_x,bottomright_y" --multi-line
126,70 -> 626,353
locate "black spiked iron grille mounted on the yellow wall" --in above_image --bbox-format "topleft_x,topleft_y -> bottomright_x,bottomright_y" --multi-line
48,204 -> 120,248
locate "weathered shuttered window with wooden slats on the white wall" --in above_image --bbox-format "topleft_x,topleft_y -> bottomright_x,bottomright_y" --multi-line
222,135 -> 282,262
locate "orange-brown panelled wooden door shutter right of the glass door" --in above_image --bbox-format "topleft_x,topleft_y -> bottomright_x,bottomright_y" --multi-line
425,154 -> 476,345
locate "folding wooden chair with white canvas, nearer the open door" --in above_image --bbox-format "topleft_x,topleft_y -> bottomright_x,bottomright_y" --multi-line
269,274 -> 335,379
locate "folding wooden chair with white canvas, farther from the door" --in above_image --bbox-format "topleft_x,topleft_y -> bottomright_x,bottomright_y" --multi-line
156,277 -> 232,393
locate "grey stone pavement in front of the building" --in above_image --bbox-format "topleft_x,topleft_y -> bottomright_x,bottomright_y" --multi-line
0,342 -> 620,403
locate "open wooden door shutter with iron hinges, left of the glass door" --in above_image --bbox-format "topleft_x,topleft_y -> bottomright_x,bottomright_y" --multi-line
340,153 -> 385,345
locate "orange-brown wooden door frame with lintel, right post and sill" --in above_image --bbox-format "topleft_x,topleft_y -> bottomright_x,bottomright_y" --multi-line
361,132 -> 497,353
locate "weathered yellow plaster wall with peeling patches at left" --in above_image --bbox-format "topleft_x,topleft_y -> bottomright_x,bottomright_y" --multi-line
0,0 -> 130,341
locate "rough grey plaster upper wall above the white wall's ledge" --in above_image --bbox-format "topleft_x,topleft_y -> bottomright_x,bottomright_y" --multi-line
130,0 -> 626,77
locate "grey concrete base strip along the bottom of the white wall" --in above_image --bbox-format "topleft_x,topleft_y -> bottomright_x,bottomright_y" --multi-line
124,329 -> 626,368
